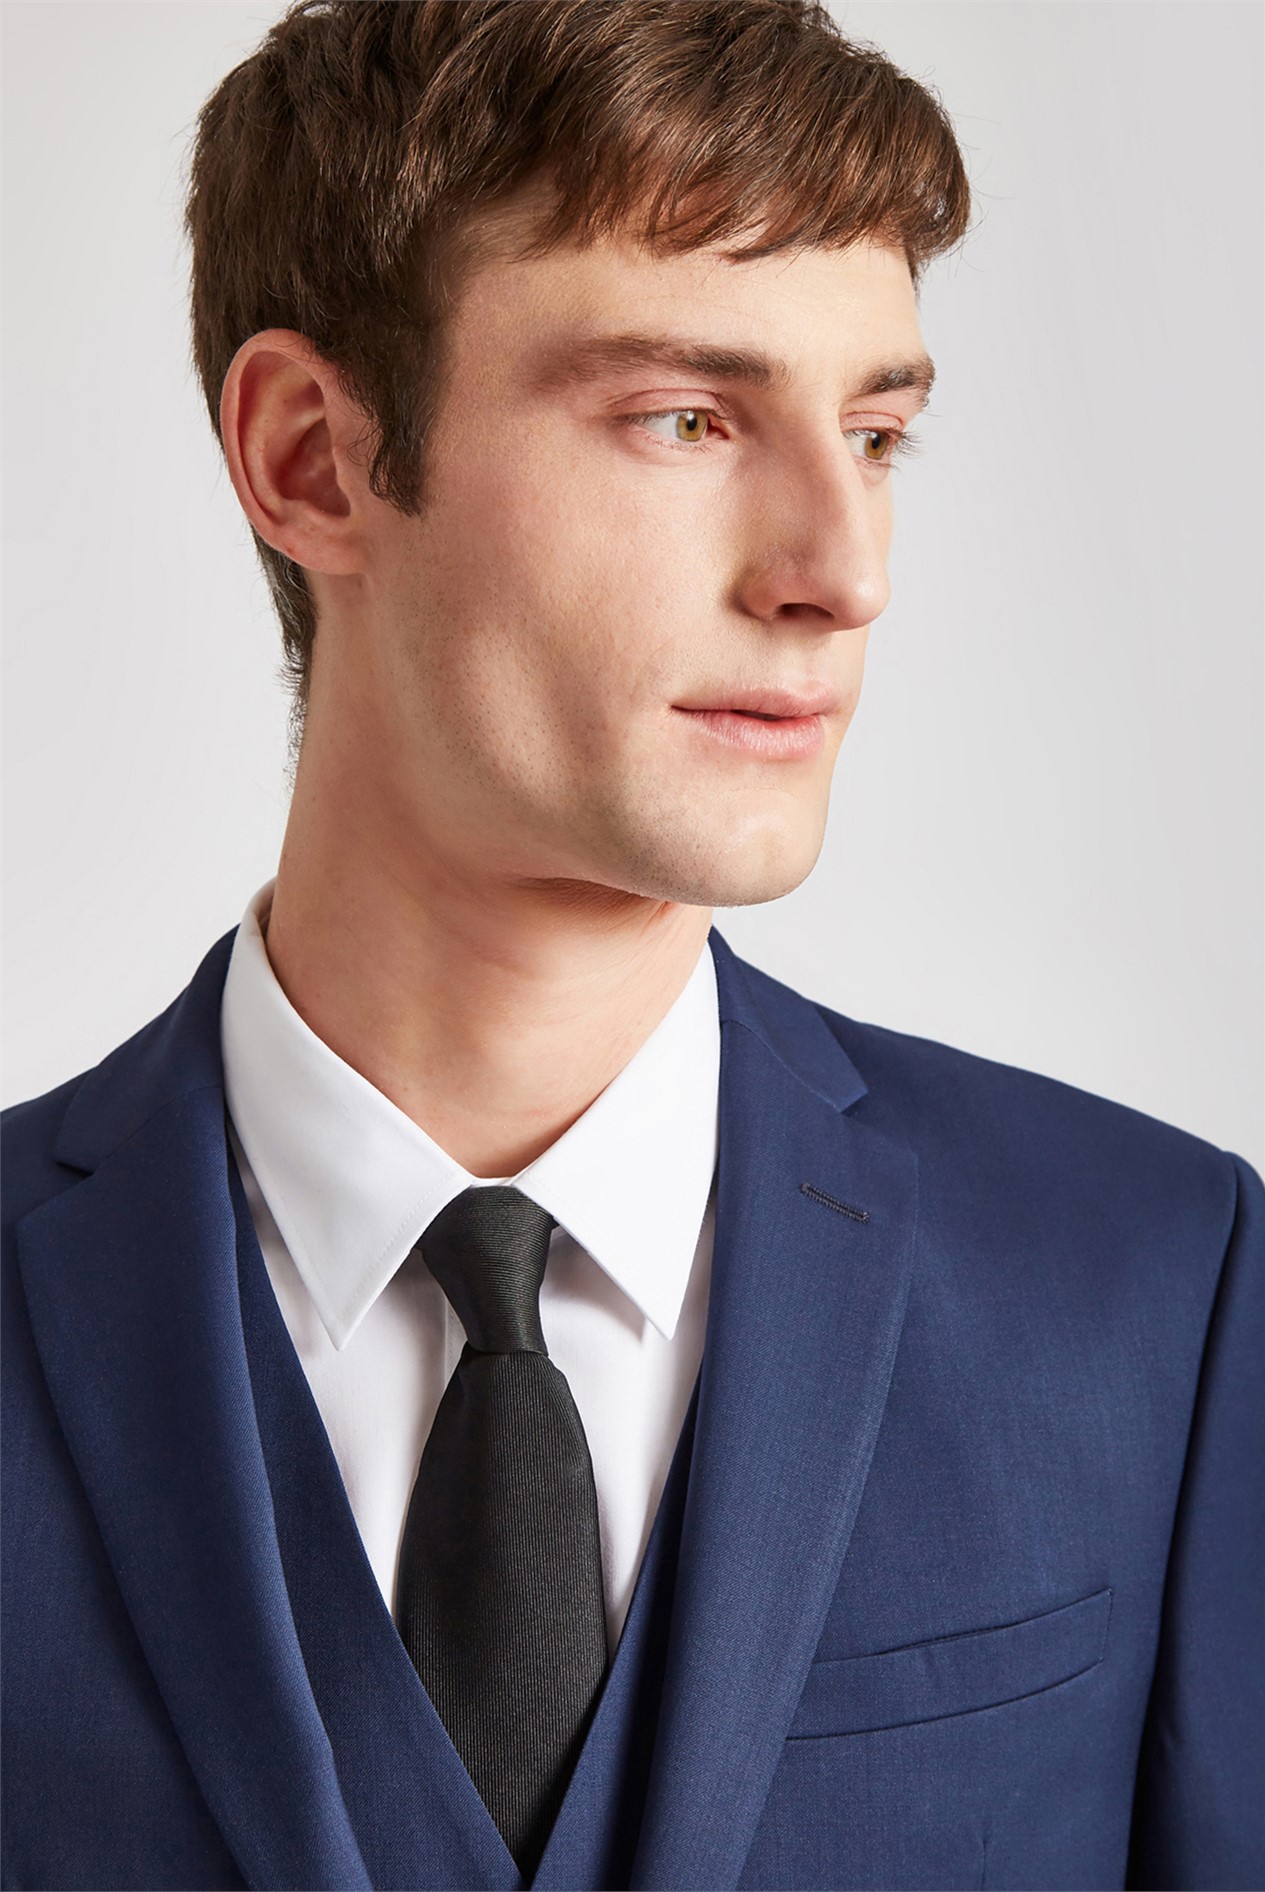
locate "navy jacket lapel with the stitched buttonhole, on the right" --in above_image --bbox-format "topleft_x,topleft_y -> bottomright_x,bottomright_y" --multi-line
632,931 -> 917,1886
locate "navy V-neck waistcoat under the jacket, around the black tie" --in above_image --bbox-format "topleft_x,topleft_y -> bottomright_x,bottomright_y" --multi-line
229,1164 -> 698,1892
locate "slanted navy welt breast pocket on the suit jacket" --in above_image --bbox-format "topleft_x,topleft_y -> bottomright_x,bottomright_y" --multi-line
787,1587 -> 1112,1741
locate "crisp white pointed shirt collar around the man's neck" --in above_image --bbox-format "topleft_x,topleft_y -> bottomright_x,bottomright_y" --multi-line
211,880 -> 720,1347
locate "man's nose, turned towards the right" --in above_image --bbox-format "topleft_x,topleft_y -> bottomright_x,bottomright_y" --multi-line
736,431 -> 891,630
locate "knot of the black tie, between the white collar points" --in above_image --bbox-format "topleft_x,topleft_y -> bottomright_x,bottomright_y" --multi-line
418,1183 -> 554,1355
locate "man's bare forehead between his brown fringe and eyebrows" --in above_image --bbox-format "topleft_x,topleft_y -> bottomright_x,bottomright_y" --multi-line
450,207 -> 923,388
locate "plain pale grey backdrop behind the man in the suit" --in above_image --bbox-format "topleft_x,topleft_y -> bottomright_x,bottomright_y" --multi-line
4,0 -> 1265,1167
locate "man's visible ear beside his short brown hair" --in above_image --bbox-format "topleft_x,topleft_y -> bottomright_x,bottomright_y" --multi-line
219,329 -> 373,575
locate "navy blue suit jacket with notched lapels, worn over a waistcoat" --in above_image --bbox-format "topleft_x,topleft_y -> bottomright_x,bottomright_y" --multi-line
4,931 -> 1265,1888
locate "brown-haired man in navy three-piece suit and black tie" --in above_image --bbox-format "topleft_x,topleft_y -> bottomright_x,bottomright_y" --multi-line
4,0 -> 1265,1888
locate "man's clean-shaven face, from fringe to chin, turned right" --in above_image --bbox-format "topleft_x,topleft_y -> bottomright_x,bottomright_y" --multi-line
334,210 -> 923,906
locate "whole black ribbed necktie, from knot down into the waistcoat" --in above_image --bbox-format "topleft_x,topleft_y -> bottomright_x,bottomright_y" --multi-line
395,1184 -> 607,1879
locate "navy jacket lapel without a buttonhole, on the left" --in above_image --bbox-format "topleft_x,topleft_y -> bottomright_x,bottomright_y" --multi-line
19,935 -> 369,1888
